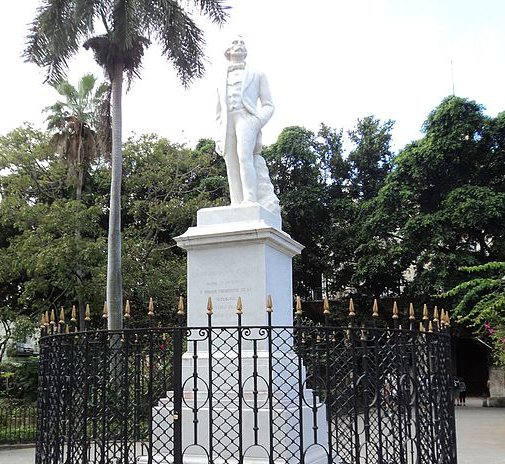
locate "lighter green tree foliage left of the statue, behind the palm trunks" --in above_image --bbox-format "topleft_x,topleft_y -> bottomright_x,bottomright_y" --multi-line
0,127 -> 227,325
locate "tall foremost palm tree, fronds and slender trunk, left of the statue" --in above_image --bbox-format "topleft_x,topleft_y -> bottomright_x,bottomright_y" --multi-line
25,0 -> 227,330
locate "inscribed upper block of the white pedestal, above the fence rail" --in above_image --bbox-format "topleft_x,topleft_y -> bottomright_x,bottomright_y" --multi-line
176,205 -> 303,327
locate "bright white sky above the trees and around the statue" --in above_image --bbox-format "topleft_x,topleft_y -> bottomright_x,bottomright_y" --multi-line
0,0 -> 505,150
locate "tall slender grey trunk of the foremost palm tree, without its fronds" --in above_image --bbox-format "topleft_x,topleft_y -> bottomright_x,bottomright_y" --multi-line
107,63 -> 123,330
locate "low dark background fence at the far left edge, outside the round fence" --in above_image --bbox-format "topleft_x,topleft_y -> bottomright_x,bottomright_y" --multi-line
0,405 -> 37,444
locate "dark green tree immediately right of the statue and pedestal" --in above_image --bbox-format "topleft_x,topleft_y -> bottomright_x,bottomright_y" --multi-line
264,126 -> 340,297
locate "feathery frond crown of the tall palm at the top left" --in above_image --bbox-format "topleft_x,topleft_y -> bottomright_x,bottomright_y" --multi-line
25,0 -> 227,84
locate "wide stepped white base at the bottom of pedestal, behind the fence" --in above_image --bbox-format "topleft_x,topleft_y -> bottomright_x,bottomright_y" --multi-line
148,390 -> 332,464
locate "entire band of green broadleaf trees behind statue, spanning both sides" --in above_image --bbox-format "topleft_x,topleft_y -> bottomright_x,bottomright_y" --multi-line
0,97 -> 505,362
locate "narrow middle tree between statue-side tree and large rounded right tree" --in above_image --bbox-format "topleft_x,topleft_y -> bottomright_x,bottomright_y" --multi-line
323,116 -> 393,296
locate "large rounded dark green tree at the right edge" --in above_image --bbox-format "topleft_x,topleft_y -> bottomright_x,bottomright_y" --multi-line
356,97 -> 505,302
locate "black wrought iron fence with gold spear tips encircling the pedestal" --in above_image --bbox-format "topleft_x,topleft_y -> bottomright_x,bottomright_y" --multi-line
36,302 -> 456,464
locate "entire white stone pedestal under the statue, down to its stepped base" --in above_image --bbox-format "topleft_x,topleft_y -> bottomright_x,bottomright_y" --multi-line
146,205 -> 332,464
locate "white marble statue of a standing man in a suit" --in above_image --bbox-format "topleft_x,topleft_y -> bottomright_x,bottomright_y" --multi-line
217,37 -> 280,214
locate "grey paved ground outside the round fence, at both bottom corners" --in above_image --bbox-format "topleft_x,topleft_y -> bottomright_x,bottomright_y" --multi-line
0,398 -> 505,464
